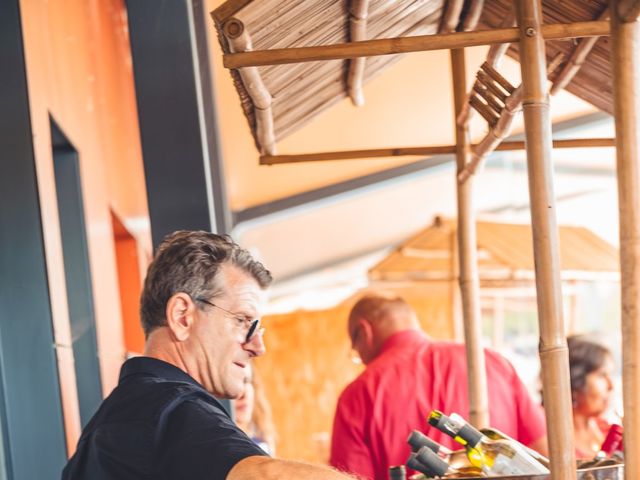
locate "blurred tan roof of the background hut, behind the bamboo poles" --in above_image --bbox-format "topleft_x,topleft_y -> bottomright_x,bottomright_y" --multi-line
369,219 -> 619,283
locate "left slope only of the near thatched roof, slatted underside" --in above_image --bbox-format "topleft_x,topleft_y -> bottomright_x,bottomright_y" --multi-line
213,0 -> 445,150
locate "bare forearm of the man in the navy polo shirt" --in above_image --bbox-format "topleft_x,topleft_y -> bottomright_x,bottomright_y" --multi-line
227,456 -> 356,480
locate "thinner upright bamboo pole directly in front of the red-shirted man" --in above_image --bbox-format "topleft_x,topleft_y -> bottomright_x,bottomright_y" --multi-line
451,49 -> 489,428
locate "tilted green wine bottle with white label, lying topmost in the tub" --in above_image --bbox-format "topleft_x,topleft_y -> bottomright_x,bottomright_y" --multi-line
429,410 -> 549,475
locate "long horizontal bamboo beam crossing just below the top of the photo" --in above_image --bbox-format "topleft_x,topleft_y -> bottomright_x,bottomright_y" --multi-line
223,21 -> 609,68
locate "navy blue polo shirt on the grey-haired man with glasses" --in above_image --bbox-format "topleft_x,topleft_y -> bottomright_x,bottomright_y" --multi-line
62,357 -> 266,480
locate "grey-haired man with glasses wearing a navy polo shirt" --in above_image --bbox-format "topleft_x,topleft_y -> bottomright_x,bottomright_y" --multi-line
62,231 -> 356,480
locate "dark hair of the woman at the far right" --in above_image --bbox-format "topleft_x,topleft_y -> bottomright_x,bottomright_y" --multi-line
567,335 -> 612,393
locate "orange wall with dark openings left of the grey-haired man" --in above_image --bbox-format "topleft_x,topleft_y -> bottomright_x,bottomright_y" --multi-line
20,0 -> 151,451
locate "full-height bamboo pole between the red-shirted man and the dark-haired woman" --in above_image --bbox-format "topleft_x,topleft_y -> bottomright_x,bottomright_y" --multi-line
514,0 -> 577,480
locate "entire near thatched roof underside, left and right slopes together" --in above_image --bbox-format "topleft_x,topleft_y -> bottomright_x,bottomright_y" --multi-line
212,0 -> 612,154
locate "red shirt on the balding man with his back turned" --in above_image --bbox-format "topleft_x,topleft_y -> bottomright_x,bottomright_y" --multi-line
330,330 -> 545,480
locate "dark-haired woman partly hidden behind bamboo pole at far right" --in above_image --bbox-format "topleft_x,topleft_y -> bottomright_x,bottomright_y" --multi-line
567,336 -> 614,458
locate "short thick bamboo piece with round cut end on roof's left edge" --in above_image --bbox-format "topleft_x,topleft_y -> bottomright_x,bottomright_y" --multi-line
223,18 -> 276,155
